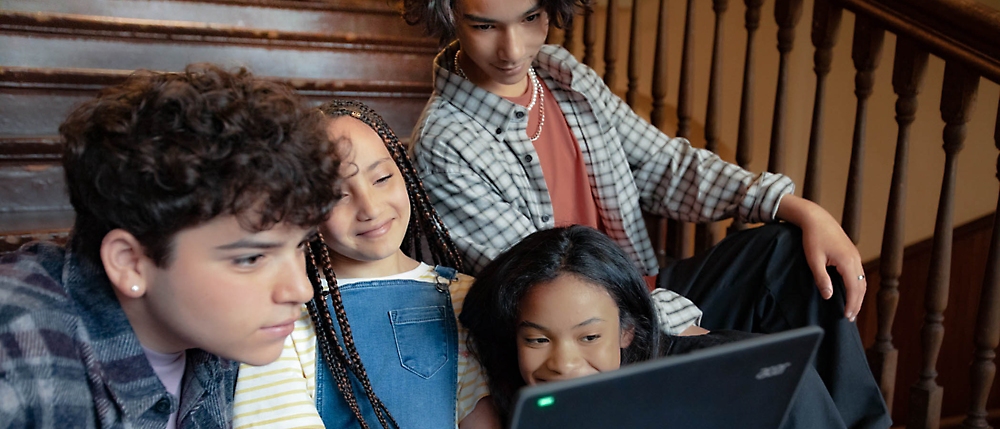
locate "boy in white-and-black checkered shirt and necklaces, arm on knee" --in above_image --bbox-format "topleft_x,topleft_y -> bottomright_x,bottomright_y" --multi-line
404,0 -> 885,421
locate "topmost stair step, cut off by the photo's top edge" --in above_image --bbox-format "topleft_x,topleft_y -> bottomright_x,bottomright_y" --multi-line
3,0 -> 423,38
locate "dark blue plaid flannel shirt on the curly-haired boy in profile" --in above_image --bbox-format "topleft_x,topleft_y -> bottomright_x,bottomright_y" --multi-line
0,243 -> 237,429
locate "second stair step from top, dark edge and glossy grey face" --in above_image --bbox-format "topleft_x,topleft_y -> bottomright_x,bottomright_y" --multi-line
0,11 -> 436,82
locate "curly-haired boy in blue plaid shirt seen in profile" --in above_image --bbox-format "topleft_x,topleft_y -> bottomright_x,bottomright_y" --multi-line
0,66 -> 338,428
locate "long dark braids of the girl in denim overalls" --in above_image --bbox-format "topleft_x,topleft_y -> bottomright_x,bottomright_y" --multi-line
306,100 -> 462,429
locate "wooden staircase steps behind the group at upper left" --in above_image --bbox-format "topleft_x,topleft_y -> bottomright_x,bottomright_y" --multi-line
0,0 -> 437,251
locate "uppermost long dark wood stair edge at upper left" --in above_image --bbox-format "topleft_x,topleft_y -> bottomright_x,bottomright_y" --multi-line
0,11 -> 437,55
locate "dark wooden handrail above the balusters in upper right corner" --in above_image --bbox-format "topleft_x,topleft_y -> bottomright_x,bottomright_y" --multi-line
836,0 -> 1000,82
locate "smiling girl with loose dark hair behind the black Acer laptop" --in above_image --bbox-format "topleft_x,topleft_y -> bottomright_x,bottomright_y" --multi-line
460,225 -> 890,429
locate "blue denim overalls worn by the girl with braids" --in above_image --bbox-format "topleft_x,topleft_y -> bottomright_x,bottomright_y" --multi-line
316,267 -> 458,429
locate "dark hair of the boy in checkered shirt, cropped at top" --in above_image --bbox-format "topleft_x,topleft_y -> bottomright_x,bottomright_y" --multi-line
403,0 -> 591,45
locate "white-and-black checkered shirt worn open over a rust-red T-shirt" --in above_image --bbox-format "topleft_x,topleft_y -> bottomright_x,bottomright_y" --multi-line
411,43 -> 795,331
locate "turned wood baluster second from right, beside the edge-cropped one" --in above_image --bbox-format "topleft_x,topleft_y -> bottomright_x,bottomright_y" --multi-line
907,61 -> 979,429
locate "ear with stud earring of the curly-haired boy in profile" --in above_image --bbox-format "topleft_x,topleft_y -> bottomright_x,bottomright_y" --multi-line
101,229 -> 149,298
